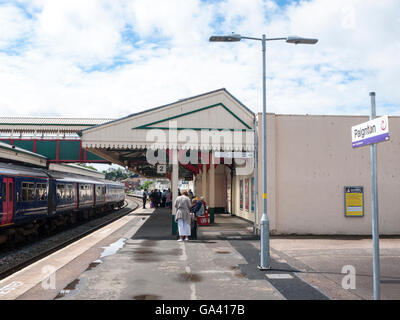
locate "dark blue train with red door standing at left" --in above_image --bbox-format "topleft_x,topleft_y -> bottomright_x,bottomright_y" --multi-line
0,163 -> 125,243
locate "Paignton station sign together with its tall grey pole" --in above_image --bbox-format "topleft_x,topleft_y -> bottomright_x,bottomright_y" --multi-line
351,92 -> 389,300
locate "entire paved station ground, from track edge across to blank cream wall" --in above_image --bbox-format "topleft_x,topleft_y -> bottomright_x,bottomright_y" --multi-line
4,208 -> 400,300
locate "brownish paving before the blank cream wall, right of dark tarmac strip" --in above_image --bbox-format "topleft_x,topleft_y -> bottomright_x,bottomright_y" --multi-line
266,237 -> 400,300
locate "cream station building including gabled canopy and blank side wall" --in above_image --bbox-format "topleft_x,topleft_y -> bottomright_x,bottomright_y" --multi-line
81,89 -> 400,235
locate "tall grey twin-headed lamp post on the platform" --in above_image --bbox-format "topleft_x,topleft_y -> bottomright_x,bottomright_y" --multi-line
209,34 -> 318,270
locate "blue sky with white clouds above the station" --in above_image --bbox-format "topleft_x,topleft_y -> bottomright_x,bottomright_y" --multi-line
0,0 -> 400,118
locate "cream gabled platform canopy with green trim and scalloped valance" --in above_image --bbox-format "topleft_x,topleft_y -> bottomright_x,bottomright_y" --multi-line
80,88 -> 255,176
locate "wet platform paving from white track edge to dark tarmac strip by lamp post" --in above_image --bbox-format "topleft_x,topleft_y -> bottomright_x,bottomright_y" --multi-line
0,208 -> 338,300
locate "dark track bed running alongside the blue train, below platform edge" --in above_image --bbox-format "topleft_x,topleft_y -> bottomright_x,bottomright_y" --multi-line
0,199 -> 139,280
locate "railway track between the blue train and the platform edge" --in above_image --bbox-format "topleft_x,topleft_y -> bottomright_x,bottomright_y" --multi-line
0,197 -> 142,280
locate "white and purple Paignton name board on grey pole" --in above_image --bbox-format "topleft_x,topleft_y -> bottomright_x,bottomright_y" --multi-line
351,116 -> 389,148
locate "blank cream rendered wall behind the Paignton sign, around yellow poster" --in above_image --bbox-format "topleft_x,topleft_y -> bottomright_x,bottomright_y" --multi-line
234,114 -> 400,235
